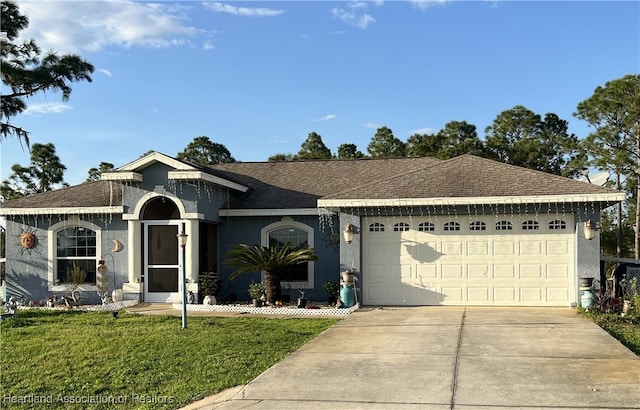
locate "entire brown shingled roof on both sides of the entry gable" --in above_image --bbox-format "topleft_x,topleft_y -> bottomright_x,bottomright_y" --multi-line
0,155 -> 617,209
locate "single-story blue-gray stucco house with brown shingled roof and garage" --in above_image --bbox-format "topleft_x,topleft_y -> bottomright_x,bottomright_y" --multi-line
0,152 -> 624,306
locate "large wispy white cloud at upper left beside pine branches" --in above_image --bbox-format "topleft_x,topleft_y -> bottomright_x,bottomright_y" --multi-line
18,0 -> 197,53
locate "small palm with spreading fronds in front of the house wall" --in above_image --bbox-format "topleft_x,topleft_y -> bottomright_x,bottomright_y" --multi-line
224,243 -> 318,304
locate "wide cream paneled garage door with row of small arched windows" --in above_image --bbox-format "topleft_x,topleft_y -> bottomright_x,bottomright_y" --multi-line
361,214 -> 576,306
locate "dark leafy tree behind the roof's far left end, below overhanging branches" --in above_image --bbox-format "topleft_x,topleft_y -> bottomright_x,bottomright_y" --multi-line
0,143 -> 67,201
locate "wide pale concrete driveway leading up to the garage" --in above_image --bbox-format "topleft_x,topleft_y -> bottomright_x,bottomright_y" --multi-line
182,307 -> 640,410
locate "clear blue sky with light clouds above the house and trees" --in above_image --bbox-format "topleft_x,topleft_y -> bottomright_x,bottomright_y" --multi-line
0,0 -> 640,184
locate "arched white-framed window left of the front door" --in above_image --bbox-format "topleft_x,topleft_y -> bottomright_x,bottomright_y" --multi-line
56,226 -> 99,285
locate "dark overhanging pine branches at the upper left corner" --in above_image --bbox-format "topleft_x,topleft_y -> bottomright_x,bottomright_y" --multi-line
0,1 -> 94,145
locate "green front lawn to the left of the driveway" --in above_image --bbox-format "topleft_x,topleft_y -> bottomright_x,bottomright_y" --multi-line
0,310 -> 338,409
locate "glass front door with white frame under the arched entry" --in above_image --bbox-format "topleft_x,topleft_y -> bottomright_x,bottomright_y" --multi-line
144,221 -> 182,302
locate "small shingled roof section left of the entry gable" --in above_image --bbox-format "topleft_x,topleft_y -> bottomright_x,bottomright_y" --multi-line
0,181 -> 122,208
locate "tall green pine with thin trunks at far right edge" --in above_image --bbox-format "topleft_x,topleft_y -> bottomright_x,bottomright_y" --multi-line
574,74 -> 640,259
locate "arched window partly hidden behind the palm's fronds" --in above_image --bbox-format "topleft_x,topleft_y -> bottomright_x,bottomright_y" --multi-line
262,219 -> 314,288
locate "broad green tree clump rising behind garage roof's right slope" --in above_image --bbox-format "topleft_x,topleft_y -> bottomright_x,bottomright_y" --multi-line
485,105 -> 581,176
